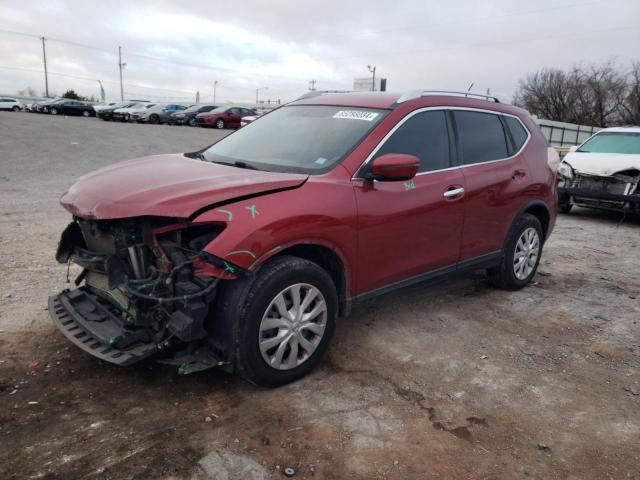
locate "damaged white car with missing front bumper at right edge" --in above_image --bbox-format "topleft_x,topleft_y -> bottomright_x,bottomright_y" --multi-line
557,127 -> 640,214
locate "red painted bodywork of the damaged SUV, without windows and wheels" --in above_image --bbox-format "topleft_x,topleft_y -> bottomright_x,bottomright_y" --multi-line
61,92 -> 556,297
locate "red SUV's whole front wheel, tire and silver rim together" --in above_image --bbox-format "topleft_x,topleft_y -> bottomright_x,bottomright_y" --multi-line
222,256 -> 338,387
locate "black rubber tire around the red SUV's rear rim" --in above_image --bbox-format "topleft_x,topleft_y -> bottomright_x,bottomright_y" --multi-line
487,213 -> 544,291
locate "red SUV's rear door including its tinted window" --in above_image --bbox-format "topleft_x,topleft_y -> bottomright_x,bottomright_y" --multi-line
453,109 -> 528,261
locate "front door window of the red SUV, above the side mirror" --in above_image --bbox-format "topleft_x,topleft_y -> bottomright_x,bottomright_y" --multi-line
374,110 -> 450,172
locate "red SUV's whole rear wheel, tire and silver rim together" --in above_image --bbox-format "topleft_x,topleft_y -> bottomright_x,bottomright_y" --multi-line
488,213 -> 543,290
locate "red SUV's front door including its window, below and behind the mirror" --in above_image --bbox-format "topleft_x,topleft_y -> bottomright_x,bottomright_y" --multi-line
354,109 -> 464,293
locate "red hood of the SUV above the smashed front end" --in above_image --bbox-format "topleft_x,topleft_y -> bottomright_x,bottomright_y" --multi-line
60,154 -> 308,219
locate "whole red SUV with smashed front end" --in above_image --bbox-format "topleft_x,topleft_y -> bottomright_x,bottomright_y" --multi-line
49,92 -> 557,386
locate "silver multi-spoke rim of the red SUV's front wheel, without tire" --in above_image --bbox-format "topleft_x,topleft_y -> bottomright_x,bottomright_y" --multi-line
258,283 -> 327,370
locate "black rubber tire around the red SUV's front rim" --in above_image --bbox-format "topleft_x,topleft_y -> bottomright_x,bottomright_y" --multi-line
215,255 -> 338,388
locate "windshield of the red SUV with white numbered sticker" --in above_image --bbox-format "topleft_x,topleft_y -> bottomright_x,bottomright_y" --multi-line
203,105 -> 386,174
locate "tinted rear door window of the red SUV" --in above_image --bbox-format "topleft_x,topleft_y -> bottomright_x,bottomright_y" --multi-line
454,110 -> 509,165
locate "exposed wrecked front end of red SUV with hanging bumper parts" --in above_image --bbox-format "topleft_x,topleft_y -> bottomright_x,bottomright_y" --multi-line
50,218 -> 235,373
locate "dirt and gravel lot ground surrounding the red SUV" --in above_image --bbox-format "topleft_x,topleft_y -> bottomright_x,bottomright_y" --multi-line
0,112 -> 640,480
